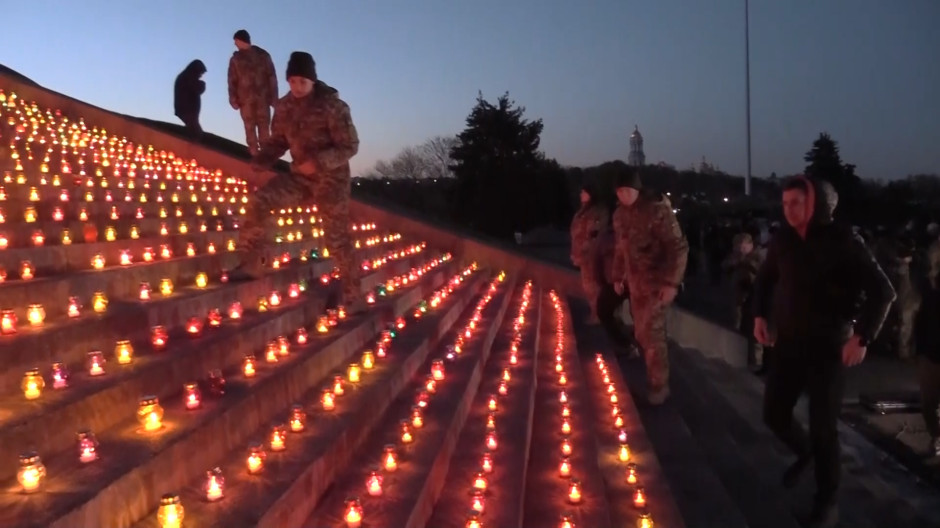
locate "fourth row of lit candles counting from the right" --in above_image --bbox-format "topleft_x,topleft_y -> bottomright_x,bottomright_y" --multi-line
343,267 -> 506,528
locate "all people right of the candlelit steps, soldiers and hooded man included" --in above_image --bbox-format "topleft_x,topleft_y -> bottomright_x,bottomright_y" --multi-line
571,174 -> 940,527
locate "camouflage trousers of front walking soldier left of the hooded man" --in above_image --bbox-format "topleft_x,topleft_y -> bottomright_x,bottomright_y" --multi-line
630,288 -> 669,392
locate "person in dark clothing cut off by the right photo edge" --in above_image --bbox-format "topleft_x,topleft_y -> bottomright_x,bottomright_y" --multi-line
914,242 -> 940,457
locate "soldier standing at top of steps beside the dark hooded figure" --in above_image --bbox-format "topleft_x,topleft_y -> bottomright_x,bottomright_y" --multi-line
228,29 -> 277,156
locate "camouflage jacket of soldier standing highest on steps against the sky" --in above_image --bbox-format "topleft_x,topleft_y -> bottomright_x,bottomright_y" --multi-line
228,46 -> 277,108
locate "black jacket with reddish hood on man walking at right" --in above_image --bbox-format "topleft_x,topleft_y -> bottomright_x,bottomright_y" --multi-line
754,178 -> 895,342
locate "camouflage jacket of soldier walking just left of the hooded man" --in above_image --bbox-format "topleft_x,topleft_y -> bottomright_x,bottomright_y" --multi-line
612,193 -> 689,292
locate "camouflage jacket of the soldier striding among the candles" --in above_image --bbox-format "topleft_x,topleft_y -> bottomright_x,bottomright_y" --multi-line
255,81 -> 359,180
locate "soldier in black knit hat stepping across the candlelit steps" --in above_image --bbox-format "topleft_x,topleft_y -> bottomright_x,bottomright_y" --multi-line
239,52 -> 362,311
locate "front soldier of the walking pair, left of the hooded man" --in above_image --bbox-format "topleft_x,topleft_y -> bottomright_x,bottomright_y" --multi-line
613,173 -> 689,405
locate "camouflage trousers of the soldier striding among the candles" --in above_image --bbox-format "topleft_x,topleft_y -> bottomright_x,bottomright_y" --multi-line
238,173 -> 360,304
